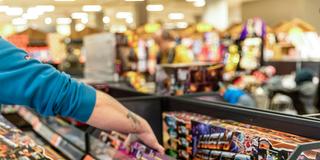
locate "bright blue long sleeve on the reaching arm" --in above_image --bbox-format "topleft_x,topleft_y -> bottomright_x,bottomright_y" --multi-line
0,38 -> 96,122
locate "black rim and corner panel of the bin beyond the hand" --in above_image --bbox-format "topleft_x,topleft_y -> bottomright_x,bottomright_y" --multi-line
117,97 -> 320,141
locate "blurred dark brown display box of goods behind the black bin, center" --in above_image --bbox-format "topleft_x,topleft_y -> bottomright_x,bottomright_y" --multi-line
156,63 -> 223,95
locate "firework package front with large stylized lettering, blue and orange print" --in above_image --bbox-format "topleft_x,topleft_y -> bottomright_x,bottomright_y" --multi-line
192,120 -> 293,160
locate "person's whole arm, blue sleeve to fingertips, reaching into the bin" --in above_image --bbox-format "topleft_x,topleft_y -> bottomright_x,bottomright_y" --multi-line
0,38 -> 163,152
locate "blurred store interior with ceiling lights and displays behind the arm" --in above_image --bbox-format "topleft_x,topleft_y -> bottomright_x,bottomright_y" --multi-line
0,0 -> 320,114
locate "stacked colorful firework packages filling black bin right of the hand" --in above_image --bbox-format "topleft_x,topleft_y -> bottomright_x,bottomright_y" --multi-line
163,112 -> 319,160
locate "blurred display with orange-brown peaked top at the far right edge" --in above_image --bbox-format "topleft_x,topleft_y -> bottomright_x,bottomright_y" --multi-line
266,19 -> 320,61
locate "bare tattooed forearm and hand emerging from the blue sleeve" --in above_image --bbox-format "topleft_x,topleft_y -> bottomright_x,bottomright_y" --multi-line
88,91 -> 164,153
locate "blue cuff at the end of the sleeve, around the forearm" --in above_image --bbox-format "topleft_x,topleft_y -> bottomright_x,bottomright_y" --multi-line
74,83 -> 96,122
